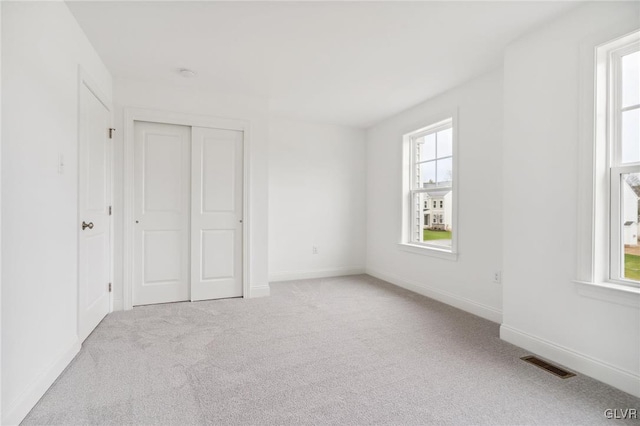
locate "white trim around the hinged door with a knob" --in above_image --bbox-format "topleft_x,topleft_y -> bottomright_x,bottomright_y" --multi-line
76,65 -> 114,328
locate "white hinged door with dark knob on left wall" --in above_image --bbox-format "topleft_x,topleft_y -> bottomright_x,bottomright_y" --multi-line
78,84 -> 111,341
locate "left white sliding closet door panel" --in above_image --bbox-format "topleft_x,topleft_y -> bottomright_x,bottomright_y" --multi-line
133,122 -> 191,305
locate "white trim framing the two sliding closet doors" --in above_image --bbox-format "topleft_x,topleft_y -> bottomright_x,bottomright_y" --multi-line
122,108 -> 251,310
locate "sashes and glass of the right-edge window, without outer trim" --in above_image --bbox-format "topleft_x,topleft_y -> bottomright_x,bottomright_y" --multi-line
605,37 -> 640,285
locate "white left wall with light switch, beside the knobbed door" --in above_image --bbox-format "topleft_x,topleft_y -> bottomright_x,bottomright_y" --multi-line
2,2 -> 111,424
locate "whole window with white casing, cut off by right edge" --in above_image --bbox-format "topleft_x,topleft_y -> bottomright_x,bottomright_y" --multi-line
577,31 -> 640,292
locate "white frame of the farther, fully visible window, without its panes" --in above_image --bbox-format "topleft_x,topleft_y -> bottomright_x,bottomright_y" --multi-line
398,109 -> 459,261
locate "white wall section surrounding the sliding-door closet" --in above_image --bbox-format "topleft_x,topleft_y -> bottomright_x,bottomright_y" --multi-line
113,80 -> 269,310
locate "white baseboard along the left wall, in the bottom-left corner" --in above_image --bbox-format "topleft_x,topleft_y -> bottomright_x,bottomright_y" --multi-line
2,340 -> 81,425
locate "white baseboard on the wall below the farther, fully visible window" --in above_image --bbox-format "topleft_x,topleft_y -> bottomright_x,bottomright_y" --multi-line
366,268 -> 502,324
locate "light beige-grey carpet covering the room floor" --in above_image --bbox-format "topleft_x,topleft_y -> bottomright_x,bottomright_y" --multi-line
24,275 -> 640,425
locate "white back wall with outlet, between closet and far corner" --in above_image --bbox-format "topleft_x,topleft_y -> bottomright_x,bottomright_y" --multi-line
269,117 -> 366,281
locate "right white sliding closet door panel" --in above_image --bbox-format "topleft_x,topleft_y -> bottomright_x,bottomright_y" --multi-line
191,127 -> 243,300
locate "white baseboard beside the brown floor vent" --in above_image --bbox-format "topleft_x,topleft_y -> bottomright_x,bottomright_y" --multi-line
500,324 -> 640,398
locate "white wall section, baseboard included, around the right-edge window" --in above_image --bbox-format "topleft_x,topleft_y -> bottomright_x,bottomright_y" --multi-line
501,2 -> 640,396
